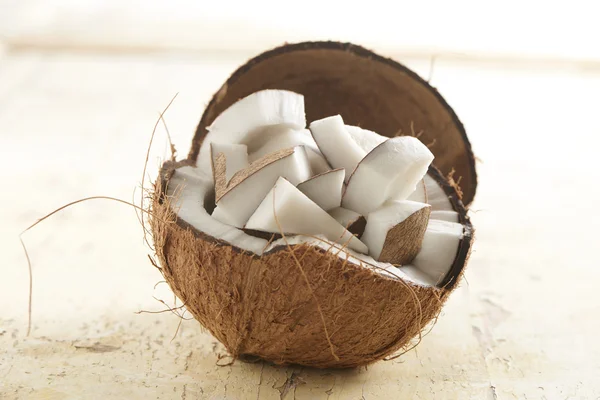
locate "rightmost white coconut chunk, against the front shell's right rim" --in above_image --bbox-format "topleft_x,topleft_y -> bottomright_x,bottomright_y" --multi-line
411,220 -> 464,284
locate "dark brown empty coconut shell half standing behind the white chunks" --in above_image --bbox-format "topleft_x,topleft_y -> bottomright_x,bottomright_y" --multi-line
189,42 -> 477,205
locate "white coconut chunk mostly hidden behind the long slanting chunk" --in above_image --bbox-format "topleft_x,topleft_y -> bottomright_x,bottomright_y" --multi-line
249,125 -> 331,174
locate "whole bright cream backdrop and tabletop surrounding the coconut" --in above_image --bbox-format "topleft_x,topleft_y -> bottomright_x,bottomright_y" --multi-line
0,0 -> 600,400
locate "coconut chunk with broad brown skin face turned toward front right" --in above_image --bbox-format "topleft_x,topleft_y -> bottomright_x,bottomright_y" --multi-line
361,200 -> 431,265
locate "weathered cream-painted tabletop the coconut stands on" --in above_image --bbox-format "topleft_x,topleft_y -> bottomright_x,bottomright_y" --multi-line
0,21 -> 600,400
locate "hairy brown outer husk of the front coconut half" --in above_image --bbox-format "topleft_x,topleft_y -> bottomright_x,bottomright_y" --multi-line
151,161 -> 472,368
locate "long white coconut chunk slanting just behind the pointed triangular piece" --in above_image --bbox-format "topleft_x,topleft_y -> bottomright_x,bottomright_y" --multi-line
212,146 -> 312,228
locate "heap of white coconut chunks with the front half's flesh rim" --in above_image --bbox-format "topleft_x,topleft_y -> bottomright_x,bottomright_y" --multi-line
167,90 -> 464,285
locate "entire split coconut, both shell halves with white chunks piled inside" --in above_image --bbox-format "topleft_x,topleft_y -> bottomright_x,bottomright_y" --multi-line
151,42 -> 477,368
